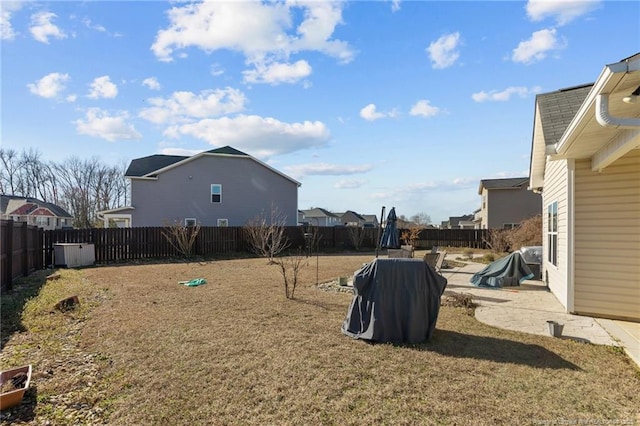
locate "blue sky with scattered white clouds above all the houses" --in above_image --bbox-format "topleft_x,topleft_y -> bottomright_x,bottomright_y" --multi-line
1,0 -> 640,223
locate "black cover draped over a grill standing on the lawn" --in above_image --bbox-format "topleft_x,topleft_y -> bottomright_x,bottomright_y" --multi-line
342,259 -> 447,344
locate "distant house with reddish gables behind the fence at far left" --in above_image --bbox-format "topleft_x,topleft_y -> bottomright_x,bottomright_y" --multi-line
0,195 -> 73,230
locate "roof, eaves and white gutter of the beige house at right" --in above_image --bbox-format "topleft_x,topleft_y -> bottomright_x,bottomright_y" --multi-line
529,53 -> 640,190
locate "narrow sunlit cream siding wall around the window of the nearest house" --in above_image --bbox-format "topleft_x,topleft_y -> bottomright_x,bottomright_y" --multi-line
542,160 -> 572,311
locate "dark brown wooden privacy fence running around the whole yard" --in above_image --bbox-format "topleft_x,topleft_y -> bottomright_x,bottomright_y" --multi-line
0,220 -> 489,291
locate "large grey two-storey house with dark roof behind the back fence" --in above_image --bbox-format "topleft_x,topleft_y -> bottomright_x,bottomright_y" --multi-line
100,146 -> 300,227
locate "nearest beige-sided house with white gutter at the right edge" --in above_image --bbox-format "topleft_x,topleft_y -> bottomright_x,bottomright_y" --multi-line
529,54 -> 640,321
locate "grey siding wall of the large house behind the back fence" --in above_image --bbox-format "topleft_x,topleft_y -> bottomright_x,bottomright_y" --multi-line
131,155 -> 298,227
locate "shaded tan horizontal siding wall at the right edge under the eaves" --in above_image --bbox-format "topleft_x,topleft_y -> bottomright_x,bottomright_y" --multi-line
574,149 -> 640,321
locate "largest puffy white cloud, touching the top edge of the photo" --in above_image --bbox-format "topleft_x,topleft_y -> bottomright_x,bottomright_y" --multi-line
151,0 -> 354,82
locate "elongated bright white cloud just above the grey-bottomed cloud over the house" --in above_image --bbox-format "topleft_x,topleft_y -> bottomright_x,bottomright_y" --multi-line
140,87 -> 246,124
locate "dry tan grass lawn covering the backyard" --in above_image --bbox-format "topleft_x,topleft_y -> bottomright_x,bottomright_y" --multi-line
0,254 -> 640,425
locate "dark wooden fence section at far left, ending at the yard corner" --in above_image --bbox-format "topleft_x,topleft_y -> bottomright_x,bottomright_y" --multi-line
0,220 -> 44,291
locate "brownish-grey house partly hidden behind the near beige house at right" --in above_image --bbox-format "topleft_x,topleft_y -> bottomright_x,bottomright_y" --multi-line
478,177 -> 542,229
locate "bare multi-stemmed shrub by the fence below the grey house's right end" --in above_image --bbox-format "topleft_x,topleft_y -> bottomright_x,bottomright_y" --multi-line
244,204 -> 289,263
